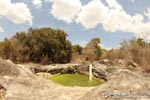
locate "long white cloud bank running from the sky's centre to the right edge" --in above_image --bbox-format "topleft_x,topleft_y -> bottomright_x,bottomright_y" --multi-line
77,0 -> 150,42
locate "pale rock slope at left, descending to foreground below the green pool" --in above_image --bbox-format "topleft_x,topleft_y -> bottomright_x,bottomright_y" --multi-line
0,61 -> 92,100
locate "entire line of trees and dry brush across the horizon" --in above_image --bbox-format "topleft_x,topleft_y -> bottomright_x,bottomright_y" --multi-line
0,28 -> 150,72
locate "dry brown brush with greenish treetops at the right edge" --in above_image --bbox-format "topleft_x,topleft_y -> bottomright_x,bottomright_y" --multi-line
101,38 -> 150,72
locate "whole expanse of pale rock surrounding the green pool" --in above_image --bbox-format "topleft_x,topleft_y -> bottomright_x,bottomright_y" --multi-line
0,60 -> 150,100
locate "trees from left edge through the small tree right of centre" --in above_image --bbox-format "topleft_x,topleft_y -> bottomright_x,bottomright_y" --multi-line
0,28 -> 102,64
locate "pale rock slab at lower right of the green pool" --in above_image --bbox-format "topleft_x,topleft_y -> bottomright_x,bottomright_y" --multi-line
78,69 -> 150,100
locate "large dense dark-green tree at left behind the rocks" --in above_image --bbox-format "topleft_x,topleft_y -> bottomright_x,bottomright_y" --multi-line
0,28 -> 72,64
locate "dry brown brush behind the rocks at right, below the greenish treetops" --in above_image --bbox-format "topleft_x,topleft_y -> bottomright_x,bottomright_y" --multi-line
101,45 -> 150,72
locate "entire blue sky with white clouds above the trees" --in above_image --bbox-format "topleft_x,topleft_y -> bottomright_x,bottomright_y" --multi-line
0,0 -> 150,48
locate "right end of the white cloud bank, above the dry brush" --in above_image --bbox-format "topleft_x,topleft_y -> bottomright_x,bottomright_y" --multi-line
102,9 -> 150,42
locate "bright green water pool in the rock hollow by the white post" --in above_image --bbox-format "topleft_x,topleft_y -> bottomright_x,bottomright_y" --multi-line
49,74 -> 102,87
